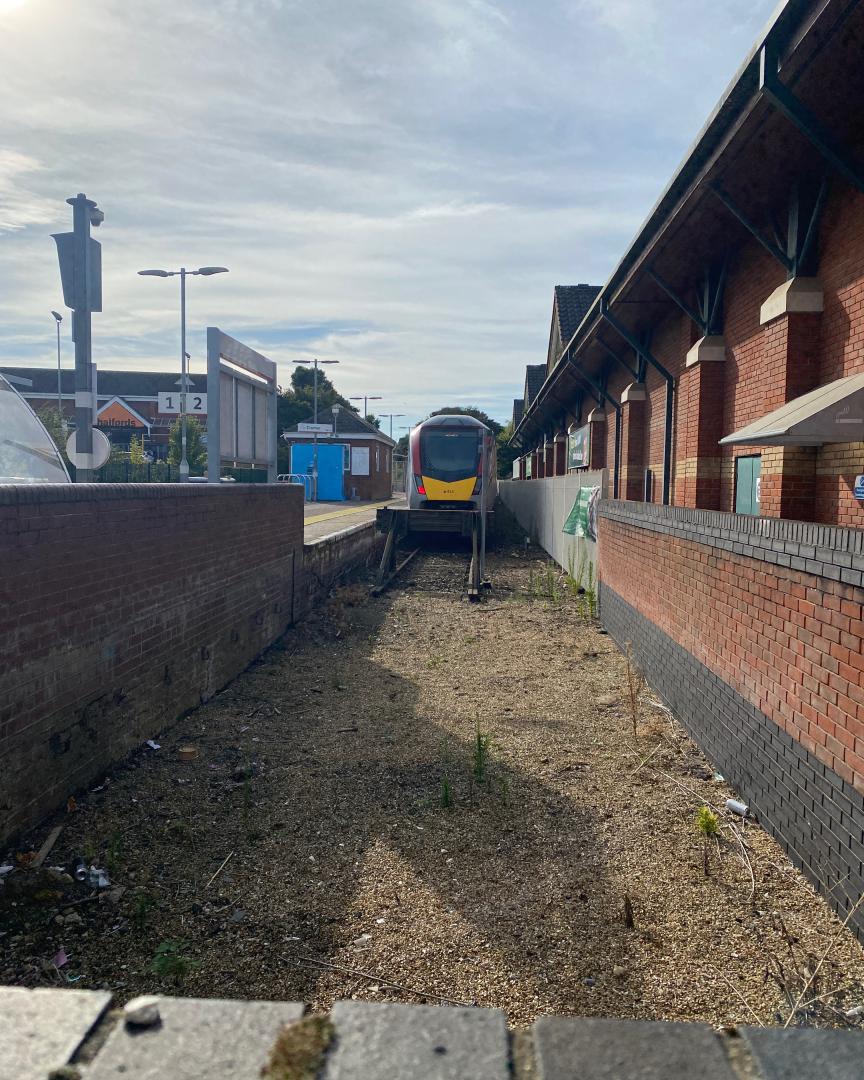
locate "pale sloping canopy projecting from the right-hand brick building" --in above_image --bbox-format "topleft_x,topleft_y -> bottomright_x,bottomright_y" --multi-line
720,375 -> 864,446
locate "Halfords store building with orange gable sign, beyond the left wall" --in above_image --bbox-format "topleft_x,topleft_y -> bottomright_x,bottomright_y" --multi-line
0,367 -> 207,460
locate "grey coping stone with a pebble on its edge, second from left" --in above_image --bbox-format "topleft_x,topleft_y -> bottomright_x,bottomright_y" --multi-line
86,998 -> 303,1080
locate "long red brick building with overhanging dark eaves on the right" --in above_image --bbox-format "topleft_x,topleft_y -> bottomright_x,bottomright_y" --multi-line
515,2 -> 864,526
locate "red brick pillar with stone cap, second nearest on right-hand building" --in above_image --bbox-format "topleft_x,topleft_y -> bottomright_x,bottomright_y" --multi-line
675,336 -> 726,510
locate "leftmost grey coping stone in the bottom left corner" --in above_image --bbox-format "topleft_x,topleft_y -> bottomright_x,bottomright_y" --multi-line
0,986 -> 111,1080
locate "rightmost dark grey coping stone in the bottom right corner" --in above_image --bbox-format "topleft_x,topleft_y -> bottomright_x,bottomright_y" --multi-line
739,1027 -> 864,1080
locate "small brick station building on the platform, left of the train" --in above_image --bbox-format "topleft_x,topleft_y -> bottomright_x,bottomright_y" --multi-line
282,408 -> 396,499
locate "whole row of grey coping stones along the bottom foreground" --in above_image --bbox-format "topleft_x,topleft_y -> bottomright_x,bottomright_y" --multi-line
0,986 -> 864,1080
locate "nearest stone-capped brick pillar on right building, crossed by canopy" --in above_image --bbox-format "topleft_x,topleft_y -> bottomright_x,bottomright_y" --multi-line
759,278 -> 823,521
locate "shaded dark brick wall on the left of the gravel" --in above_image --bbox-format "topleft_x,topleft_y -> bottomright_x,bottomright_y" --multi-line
0,484 -> 302,839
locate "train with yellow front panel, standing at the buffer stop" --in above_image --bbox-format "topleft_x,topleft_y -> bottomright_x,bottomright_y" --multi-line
406,414 -> 498,511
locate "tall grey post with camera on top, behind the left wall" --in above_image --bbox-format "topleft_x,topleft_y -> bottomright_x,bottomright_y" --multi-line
66,192 -> 96,484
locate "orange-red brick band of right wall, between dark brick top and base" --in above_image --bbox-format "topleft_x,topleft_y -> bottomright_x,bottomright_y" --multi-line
599,509 -> 864,791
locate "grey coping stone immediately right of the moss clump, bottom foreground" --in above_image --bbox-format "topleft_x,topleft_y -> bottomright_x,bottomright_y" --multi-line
324,1001 -> 510,1080
